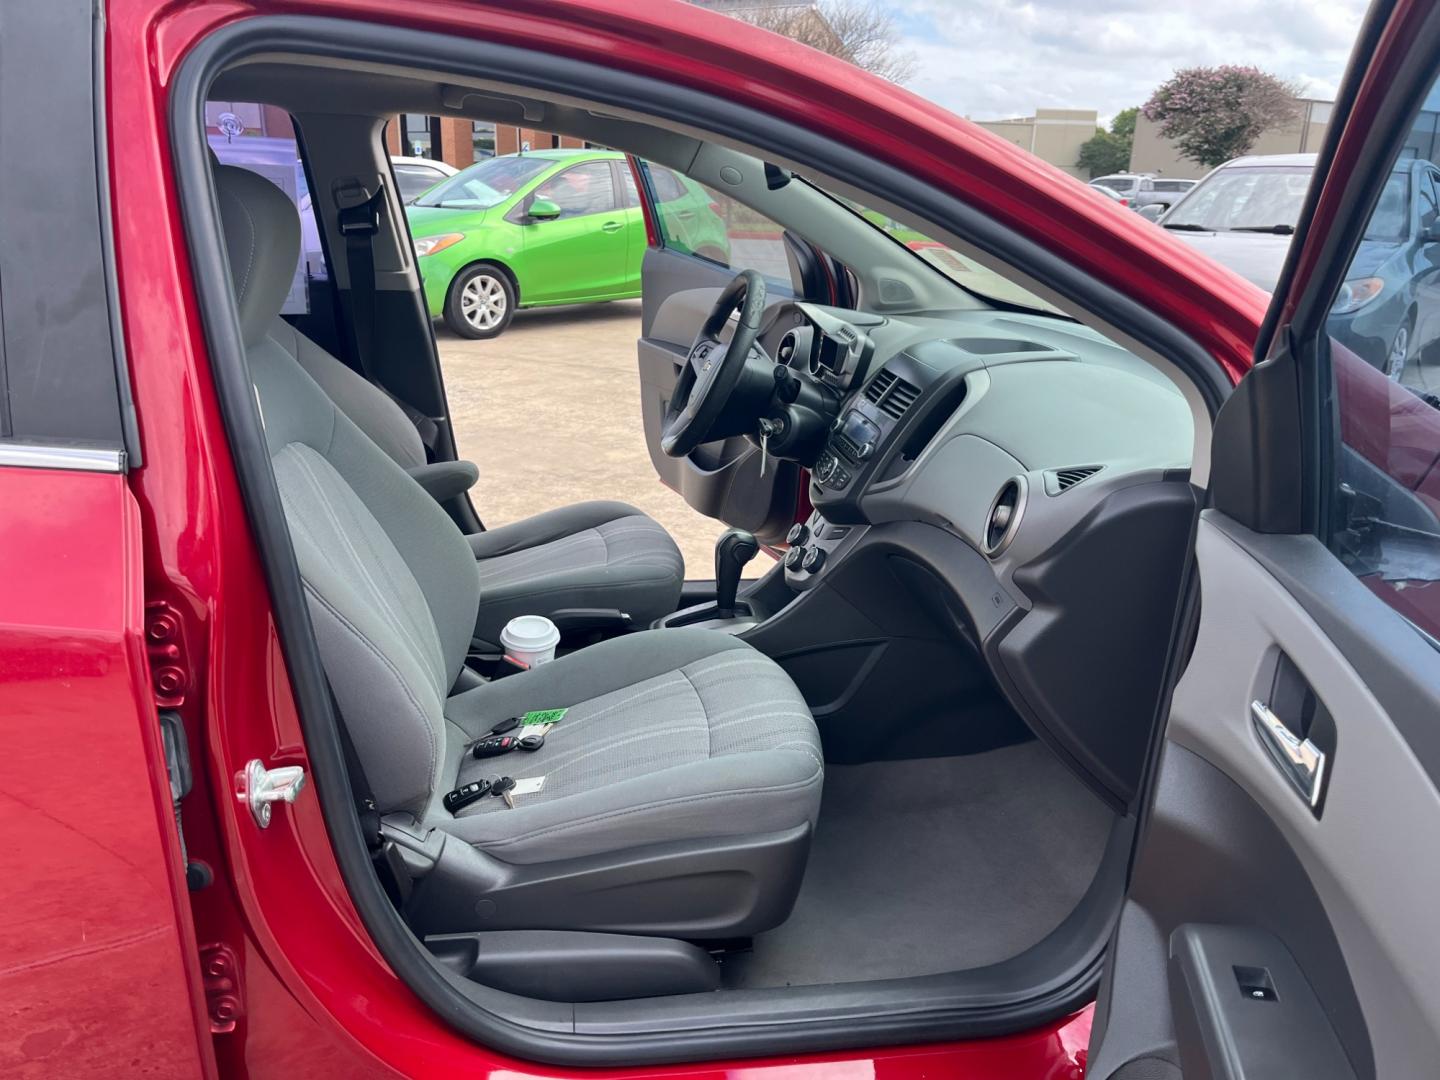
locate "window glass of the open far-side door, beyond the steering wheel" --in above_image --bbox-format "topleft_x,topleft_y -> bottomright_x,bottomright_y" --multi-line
642,161 -> 793,289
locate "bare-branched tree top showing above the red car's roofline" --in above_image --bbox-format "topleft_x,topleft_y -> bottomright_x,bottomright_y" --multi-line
711,0 -> 914,82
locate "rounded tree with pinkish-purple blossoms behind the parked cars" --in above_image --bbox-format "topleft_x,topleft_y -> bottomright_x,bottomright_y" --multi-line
1143,65 -> 1300,168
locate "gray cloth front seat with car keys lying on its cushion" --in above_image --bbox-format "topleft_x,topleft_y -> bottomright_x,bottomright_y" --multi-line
216,160 -> 822,937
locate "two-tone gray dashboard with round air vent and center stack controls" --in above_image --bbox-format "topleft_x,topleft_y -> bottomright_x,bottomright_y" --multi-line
760,301 -> 1195,806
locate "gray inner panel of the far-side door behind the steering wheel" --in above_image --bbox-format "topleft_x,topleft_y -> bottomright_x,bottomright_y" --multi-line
636,248 -> 801,543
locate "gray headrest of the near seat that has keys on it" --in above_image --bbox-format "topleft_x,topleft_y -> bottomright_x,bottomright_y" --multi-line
215,166 -> 300,346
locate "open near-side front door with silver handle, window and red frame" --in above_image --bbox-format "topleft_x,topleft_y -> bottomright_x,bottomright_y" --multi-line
1087,0 -> 1440,1080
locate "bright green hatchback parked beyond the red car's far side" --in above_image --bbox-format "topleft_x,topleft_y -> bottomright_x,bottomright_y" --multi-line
406,150 -> 729,337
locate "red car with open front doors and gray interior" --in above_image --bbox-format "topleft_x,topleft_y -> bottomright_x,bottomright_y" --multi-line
11,0 -> 1440,1080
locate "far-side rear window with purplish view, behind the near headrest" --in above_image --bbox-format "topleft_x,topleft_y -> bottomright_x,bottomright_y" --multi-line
204,101 -> 330,315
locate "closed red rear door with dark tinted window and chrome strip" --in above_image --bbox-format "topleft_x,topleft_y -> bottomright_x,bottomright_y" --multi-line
0,3 -> 215,1077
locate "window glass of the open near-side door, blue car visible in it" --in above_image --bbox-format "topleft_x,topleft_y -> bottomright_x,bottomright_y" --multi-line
1326,80 -> 1440,638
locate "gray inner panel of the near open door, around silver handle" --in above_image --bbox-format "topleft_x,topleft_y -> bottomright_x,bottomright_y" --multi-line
1092,511 -> 1440,1077
